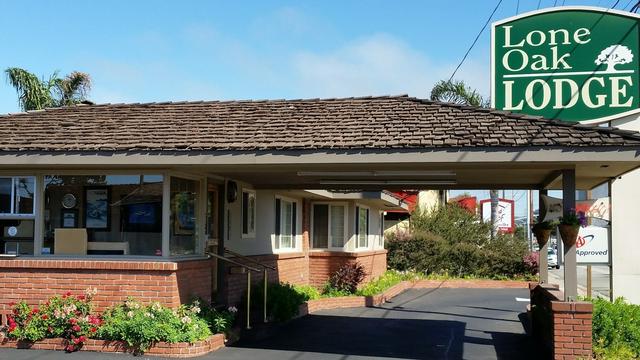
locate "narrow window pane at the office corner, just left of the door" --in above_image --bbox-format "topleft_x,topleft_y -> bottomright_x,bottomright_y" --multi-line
169,177 -> 199,255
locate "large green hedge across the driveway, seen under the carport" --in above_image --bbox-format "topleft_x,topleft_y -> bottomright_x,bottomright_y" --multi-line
387,205 -> 533,279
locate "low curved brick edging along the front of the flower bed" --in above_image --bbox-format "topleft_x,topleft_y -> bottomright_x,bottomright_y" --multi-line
0,334 -> 224,358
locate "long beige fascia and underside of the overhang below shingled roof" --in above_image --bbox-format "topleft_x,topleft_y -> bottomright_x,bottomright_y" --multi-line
0,146 -> 640,190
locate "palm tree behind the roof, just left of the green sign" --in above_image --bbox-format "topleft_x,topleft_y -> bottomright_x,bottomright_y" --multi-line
431,80 -> 499,239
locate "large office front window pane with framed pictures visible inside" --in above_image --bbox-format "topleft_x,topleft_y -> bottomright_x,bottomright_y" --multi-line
42,174 -> 162,256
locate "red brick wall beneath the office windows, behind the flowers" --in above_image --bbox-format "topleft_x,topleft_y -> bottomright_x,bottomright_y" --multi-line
0,259 -> 213,323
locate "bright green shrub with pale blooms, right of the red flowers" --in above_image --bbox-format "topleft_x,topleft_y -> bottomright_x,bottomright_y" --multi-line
97,299 -> 211,352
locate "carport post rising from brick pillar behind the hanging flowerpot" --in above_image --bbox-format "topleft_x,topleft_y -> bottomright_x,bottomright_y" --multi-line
562,169 -> 578,301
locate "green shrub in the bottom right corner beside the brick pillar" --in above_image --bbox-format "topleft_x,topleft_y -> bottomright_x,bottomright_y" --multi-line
592,298 -> 640,359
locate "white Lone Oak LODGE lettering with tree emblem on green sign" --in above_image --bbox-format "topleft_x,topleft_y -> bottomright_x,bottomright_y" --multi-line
500,25 -> 635,111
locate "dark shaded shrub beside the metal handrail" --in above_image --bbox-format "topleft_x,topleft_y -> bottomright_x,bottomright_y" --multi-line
251,283 -> 309,321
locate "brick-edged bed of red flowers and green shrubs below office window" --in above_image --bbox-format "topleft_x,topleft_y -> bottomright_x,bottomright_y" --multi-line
0,289 -> 236,357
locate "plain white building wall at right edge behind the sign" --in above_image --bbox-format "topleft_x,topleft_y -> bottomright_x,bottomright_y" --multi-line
611,118 -> 640,304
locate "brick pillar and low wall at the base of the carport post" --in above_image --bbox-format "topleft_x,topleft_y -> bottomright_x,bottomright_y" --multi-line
530,284 -> 593,360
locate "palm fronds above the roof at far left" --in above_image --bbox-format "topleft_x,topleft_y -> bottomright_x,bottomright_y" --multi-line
4,67 -> 91,111
